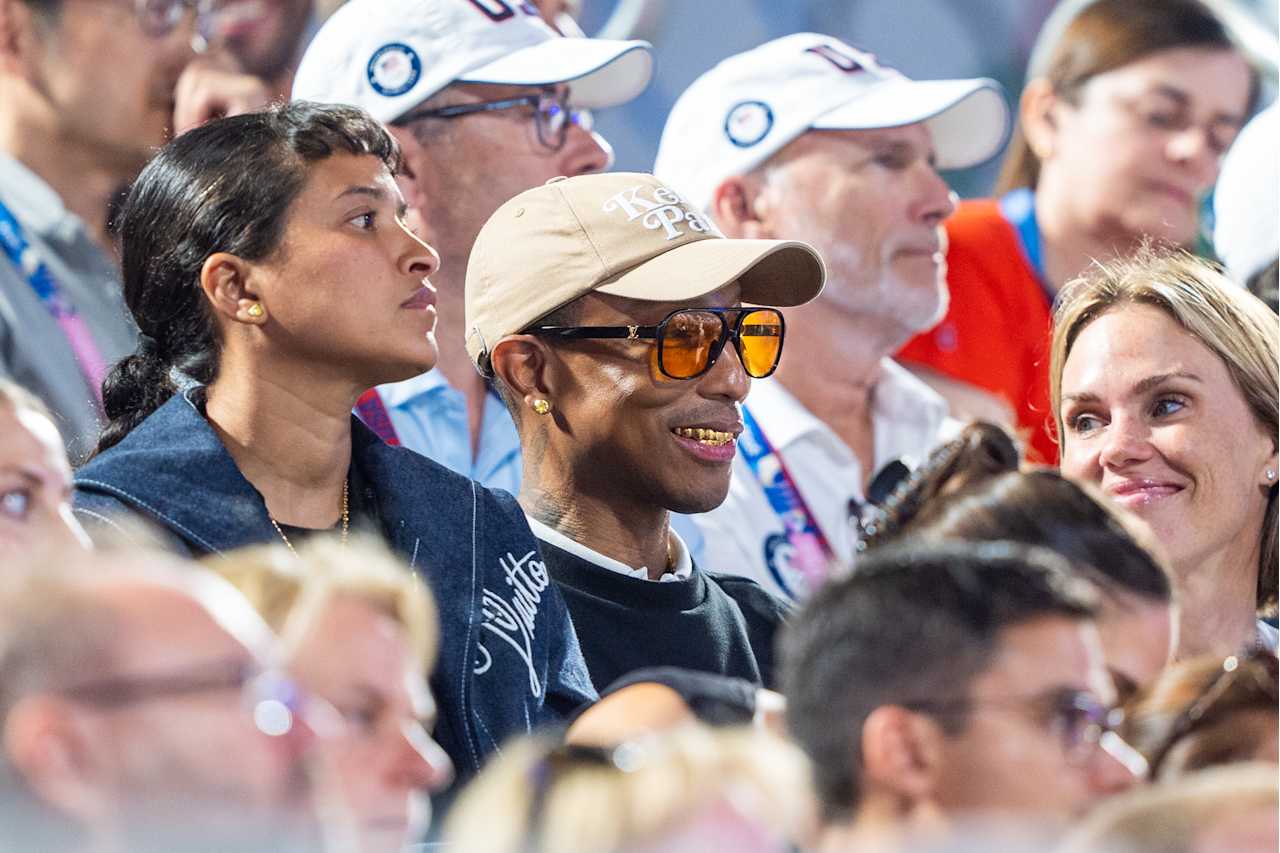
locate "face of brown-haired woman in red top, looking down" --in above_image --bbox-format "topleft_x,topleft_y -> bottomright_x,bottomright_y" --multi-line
1041,47 -> 1249,245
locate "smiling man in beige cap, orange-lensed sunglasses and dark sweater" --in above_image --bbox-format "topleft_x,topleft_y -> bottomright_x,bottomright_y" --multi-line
466,173 -> 824,688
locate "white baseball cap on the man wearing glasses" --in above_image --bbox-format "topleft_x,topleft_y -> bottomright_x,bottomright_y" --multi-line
292,0 -> 653,122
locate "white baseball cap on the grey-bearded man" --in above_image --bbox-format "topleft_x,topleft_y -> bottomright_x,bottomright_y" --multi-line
654,32 -> 1011,209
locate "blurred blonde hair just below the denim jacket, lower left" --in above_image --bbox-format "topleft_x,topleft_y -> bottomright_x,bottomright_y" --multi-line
202,535 -> 439,674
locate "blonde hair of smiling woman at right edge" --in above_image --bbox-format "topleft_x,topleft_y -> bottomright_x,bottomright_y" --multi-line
1050,245 -> 1280,610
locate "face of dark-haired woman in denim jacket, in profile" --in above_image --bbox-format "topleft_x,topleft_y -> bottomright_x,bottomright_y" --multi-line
247,154 -> 439,387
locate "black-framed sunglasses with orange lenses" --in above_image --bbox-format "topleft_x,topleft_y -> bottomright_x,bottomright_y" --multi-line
525,307 -> 786,379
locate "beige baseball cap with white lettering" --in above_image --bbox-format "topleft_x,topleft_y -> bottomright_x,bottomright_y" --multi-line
466,172 -> 827,374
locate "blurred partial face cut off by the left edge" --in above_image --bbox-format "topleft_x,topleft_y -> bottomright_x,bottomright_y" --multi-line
0,401 -> 88,555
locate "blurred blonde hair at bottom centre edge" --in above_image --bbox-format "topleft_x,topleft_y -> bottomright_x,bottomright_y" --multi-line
444,725 -> 813,853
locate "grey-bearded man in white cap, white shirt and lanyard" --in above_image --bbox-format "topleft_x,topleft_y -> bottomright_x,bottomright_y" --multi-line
654,33 -> 1009,598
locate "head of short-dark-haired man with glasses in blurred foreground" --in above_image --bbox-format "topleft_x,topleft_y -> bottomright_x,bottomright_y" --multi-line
781,543 -> 1133,849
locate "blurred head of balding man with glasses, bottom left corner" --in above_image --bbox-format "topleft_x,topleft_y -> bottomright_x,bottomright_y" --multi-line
0,552 -> 319,853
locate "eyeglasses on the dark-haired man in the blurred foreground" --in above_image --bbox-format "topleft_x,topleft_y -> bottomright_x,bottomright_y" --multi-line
899,690 -> 1126,774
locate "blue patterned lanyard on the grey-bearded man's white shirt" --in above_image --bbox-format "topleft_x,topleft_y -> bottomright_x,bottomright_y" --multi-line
737,406 -> 835,598
